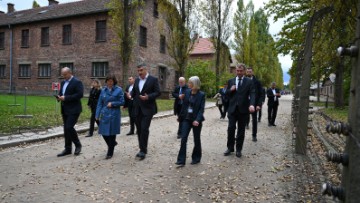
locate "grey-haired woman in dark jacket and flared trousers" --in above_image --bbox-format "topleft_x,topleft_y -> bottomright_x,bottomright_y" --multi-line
175,76 -> 205,166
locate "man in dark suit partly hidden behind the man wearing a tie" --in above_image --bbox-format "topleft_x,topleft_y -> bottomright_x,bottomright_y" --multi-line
246,67 -> 265,142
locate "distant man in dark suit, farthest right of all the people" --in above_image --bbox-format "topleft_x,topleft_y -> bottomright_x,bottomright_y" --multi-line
266,82 -> 281,126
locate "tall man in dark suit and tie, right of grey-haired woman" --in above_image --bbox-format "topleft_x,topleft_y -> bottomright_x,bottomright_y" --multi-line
224,64 -> 255,158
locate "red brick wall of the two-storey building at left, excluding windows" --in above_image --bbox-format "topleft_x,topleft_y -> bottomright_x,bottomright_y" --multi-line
0,1 -> 175,94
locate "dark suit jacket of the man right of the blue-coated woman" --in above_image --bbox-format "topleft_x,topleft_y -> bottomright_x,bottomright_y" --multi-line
131,75 -> 161,116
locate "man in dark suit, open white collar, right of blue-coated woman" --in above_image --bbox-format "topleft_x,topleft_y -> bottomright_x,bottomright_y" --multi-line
131,63 -> 161,160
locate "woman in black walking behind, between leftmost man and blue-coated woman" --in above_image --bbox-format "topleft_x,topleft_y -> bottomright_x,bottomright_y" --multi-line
85,79 -> 101,137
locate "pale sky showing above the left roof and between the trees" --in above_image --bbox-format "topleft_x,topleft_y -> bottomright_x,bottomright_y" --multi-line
0,0 -> 292,83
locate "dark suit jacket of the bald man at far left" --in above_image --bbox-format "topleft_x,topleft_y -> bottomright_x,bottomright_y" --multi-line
59,77 -> 84,115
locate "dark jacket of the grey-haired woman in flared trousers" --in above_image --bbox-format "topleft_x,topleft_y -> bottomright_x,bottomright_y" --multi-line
179,89 -> 205,123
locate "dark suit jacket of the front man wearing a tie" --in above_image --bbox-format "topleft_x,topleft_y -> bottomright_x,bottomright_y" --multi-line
226,77 -> 255,115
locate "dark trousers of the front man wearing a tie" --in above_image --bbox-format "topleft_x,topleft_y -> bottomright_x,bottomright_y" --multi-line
227,109 -> 249,152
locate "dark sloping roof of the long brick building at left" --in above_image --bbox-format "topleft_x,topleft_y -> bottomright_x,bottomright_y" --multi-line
0,0 -> 110,26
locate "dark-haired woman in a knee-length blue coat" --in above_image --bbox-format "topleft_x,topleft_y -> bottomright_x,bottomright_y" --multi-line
95,75 -> 125,159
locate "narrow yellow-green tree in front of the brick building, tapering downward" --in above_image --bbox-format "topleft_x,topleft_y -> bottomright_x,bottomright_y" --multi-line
108,0 -> 144,85
